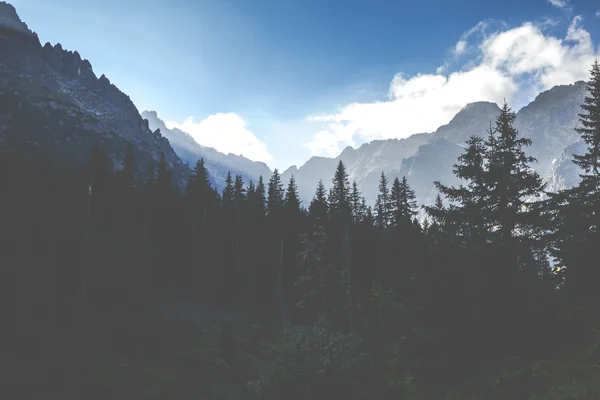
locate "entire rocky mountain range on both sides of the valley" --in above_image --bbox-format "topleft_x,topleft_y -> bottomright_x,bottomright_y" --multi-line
0,2 -> 585,206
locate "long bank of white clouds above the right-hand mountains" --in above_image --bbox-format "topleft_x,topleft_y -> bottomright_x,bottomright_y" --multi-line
306,17 -> 598,156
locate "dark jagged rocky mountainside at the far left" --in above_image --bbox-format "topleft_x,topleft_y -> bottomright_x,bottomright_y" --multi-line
0,2 -> 190,184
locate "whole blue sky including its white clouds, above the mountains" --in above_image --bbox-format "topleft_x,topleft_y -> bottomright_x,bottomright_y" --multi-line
11,0 -> 600,169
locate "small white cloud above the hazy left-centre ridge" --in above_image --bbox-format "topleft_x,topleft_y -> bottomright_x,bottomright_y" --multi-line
166,113 -> 273,162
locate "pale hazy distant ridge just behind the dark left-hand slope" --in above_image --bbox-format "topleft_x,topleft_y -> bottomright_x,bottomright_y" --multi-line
142,111 -> 271,190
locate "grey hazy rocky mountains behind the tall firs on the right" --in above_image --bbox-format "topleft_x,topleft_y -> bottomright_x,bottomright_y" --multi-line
284,82 -> 586,204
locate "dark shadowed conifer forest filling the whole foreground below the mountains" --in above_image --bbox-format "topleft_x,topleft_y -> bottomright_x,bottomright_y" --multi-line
0,63 -> 600,399
